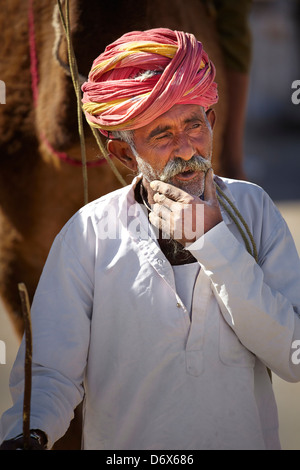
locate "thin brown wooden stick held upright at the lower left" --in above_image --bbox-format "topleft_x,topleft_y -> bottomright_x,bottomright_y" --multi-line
18,283 -> 32,450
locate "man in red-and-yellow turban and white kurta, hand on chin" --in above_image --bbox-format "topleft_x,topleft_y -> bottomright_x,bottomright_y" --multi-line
1,29 -> 300,450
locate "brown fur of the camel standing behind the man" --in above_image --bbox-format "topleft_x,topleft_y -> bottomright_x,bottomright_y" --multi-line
0,0 -> 226,448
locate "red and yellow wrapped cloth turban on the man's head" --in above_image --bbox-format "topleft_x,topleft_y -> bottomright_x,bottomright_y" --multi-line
82,28 -> 218,135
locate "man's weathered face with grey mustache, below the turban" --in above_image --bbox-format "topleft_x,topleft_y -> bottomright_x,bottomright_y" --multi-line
134,105 -> 214,196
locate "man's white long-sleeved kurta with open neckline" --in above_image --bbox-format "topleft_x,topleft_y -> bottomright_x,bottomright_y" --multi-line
0,174 -> 300,450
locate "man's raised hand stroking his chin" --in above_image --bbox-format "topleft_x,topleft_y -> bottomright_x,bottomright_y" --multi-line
149,170 -> 222,246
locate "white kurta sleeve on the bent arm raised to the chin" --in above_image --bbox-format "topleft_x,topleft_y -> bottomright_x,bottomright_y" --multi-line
189,190 -> 300,382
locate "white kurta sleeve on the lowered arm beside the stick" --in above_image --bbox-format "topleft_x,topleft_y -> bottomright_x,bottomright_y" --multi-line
0,213 -> 93,447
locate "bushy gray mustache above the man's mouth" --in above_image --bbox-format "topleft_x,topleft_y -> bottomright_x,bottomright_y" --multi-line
160,155 -> 211,181
